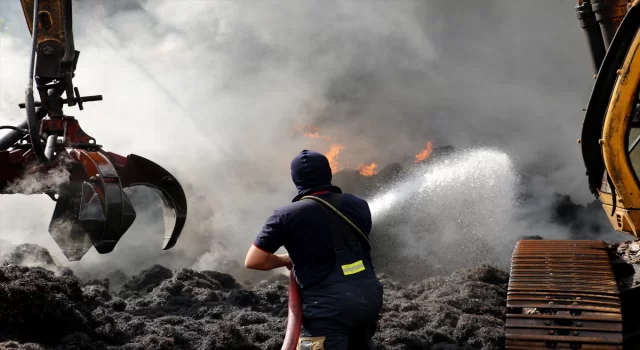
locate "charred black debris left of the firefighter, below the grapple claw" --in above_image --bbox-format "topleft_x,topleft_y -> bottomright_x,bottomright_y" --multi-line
0,246 -> 287,349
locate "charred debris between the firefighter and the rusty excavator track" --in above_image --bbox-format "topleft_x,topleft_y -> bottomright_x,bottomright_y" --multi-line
375,265 -> 509,349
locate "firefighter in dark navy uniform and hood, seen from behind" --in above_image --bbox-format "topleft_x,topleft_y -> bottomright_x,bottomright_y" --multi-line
245,150 -> 383,350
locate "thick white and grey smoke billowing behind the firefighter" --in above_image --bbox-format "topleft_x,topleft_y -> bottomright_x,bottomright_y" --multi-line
0,0 -> 632,279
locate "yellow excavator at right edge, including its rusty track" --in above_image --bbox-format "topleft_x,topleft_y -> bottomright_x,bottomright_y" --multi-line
506,0 -> 640,350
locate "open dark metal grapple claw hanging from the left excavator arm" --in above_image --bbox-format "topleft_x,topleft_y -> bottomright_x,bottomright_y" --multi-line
44,149 -> 187,260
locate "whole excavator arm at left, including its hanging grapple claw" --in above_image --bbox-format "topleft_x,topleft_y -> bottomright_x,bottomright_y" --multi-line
0,0 -> 187,260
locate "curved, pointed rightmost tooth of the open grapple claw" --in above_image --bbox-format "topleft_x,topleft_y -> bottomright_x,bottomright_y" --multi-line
107,153 -> 187,250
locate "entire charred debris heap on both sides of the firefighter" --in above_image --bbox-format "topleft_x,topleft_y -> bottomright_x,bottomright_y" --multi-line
0,246 -> 508,349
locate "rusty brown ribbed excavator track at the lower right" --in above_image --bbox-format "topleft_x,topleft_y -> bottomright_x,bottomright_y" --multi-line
506,240 -> 623,350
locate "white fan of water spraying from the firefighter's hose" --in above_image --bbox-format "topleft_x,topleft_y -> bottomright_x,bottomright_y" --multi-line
369,148 -> 523,279
